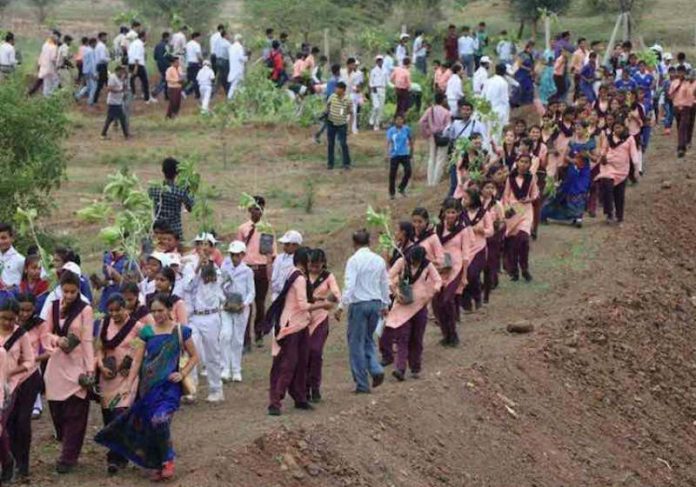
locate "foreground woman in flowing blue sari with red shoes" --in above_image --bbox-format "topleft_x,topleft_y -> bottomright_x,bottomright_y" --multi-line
95,294 -> 198,481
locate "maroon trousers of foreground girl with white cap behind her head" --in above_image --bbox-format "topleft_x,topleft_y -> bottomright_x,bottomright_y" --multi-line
48,396 -> 89,465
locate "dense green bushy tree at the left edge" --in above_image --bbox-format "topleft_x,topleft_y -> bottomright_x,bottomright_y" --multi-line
0,76 -> 68,221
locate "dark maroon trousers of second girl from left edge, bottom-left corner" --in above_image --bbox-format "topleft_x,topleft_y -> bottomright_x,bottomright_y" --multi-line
6,370 -> 43,468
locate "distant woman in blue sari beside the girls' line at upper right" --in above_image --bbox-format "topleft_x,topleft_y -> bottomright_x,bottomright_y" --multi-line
541,121 -> 597,228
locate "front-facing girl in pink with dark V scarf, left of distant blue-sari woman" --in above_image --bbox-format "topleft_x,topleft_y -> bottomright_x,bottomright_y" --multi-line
503,156 -> 539,282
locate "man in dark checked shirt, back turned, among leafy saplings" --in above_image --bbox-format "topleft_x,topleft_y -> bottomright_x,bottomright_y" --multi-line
148,157 -> 193,240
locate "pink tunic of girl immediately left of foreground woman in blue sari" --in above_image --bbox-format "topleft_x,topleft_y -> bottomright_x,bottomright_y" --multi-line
99,321 -> 145,408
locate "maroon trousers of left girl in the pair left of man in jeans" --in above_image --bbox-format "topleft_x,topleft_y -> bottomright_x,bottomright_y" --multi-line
269,328 -> 309,408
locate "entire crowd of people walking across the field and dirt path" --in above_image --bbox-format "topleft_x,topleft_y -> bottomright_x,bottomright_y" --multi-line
0,11 -> 696,481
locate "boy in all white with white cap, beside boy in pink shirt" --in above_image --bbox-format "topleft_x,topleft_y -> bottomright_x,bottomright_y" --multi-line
220,240 -> 256,382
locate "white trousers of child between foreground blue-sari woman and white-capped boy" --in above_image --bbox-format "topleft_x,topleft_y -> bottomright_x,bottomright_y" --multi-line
189,313 -> 222,392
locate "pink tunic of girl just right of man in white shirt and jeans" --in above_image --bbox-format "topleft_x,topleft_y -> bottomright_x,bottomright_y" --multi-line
385,259 -> 442,328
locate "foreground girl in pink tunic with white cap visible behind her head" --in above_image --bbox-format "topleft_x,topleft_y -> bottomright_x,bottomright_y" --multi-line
42,271 -> 95,473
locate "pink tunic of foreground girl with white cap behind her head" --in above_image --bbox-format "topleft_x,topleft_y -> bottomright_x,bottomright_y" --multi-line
42,303 -> 94,401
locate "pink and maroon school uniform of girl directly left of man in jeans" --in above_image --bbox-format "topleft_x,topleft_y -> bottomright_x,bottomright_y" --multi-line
307,271 -> 341,397
